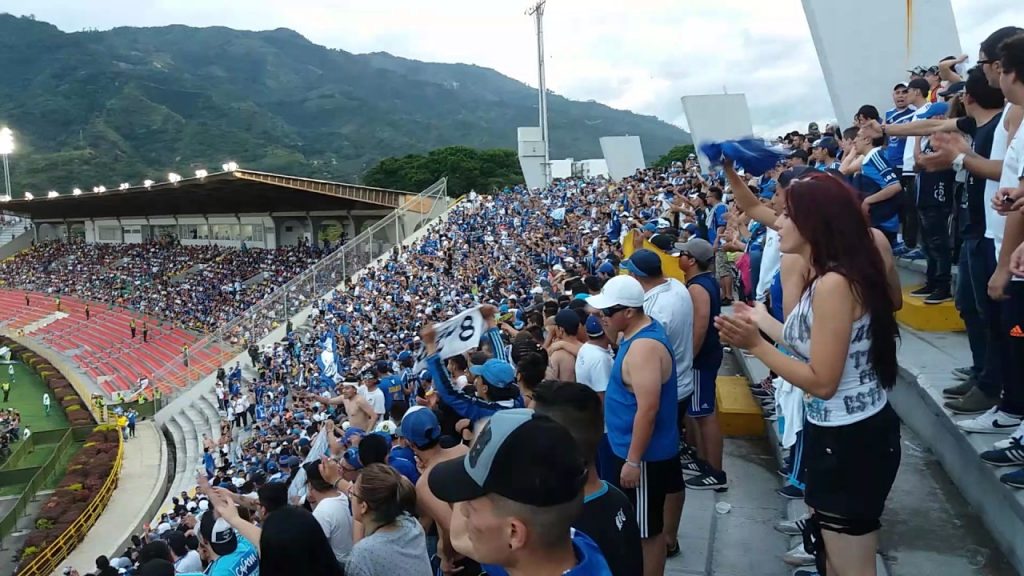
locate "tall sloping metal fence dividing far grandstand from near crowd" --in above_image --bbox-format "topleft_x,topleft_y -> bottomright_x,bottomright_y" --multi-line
150,178 -> 447,405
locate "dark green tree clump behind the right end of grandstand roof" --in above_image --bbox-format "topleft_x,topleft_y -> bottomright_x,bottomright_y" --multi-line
362,146 -> 523,196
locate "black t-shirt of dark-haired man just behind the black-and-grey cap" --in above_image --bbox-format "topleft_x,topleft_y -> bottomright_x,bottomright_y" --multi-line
572,481 -> 643,576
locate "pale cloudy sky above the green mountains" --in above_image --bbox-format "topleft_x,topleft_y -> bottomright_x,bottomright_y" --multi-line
0,0 -> 1024,134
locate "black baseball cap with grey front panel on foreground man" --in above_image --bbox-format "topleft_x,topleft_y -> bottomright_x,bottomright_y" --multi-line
427,408 -> 587,507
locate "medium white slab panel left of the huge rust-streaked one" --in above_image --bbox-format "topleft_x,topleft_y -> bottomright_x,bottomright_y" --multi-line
681,94 -> 754,172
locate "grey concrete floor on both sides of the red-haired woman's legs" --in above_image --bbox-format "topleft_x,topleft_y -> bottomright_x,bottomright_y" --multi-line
665,427 -> 1017,576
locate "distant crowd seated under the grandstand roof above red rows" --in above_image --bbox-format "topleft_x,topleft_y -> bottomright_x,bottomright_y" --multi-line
0,239 -> 328,332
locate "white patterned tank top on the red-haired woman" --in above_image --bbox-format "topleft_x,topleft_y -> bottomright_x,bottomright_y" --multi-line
782,281 -> 887,426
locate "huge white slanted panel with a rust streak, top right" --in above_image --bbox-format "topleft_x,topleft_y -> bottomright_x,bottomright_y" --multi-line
803,0 -> 963,127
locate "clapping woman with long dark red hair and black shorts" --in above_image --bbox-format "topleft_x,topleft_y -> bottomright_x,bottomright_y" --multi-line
716,172 -> 900,576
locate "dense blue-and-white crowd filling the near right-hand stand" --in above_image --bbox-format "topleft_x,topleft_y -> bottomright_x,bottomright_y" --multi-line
36,28 -> 1024,576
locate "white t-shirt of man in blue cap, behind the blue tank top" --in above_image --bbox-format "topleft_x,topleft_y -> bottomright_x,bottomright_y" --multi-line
643,278 -> 693,400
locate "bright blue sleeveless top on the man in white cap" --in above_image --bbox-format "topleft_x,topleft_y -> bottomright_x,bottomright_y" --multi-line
604,319 -> 679,461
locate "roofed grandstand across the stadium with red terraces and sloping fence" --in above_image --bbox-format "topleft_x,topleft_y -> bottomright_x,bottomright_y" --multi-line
0,170 -> 447,569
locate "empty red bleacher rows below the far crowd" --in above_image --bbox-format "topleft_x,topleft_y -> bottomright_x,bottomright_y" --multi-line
0,290 -> 230,397
